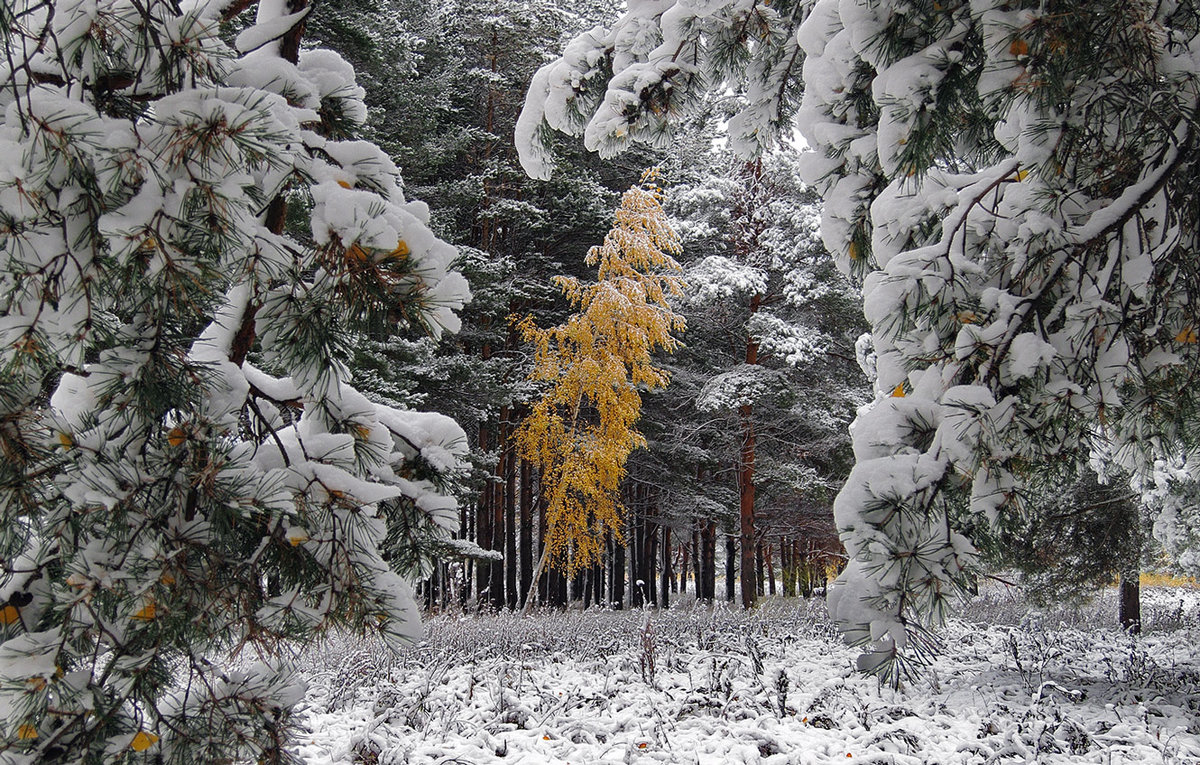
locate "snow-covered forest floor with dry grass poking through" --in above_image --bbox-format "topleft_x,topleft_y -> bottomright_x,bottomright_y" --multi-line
290,588 -> 1200,765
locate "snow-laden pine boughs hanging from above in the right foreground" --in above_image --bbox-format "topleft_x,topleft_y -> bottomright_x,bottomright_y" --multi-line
518,0 -> 1200,677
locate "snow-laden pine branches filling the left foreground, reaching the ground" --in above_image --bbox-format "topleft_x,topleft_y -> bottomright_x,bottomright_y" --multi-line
0,0 -> 469,763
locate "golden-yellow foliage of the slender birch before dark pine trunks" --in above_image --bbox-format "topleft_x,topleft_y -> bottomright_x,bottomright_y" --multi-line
516,169 -> 684,570
